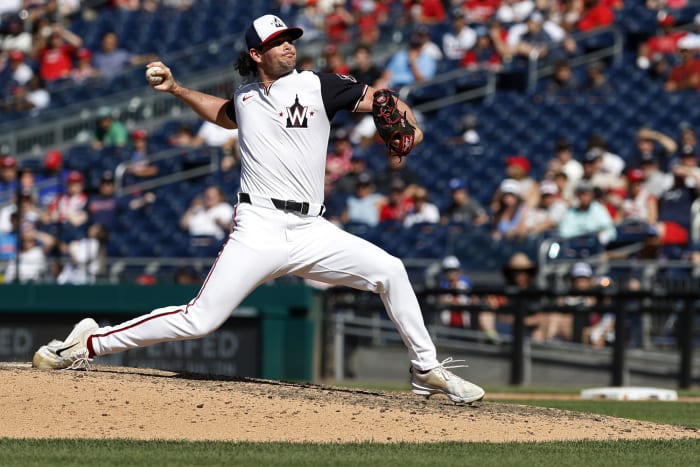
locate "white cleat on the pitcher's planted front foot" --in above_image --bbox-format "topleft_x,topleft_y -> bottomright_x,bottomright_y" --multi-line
411,357 -> 486,404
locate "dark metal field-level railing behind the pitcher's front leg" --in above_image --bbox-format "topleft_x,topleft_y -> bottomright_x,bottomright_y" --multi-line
325,288 -> 700,388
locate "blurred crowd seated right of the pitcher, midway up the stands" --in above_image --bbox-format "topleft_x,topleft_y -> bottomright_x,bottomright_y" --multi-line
320,113 -> 700,272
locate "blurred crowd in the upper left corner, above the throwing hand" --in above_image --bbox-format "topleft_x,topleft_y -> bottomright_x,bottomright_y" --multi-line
0,0 -> 178,115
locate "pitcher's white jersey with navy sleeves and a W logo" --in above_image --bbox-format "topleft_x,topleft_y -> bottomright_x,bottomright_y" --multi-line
226,71 -> 367,203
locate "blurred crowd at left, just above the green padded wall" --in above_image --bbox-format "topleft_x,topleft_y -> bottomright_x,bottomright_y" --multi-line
0,142 -> 155,284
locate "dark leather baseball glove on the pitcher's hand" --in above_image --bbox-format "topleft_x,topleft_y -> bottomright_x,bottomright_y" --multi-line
372,89 -> 416,159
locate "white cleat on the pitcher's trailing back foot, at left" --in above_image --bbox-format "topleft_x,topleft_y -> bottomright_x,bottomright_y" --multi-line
32,318 -> 99,370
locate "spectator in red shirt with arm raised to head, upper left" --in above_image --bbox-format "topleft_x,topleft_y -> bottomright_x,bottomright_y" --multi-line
38,24 -> 83,82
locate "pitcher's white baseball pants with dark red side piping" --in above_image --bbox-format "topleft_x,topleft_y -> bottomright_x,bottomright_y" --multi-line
88,204 -> 438,370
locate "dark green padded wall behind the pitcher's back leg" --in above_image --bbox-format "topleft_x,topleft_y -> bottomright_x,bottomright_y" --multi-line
0,284 -> 321,380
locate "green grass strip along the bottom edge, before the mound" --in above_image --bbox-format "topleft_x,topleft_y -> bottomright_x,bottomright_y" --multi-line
0,440 -> 698,467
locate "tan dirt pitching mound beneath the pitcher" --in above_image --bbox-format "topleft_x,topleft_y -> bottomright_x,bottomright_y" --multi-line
0,363 -> 700,442
